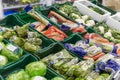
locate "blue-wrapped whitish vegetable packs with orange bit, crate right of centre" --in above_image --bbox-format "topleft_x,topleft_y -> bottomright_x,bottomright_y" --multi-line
65,41 -> 105,60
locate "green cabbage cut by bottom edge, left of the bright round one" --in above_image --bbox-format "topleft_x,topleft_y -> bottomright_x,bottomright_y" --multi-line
6,69 -> 30,80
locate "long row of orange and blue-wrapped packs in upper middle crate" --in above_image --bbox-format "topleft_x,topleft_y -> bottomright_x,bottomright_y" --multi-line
40,10 -> 86,32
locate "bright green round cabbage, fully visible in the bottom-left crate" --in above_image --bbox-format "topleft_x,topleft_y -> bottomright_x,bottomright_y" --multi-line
25,61 -> 47,77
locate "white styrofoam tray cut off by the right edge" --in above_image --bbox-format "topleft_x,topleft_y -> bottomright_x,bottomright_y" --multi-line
106,13 -> 120,30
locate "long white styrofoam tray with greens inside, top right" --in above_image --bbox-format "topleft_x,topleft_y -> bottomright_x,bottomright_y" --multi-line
73,0 -> 111,22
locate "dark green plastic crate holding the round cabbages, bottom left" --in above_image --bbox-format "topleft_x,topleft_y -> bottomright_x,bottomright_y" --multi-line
0,54 -> 60,80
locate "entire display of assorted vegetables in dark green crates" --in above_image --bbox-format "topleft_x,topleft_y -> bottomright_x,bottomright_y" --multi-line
0,0 -> 120,80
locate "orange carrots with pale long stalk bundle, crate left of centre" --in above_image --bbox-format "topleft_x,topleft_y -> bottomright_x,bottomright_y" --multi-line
28,10 -> 67,41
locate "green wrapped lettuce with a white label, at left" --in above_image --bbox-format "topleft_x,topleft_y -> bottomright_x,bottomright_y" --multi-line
1,44 -> 23,61
